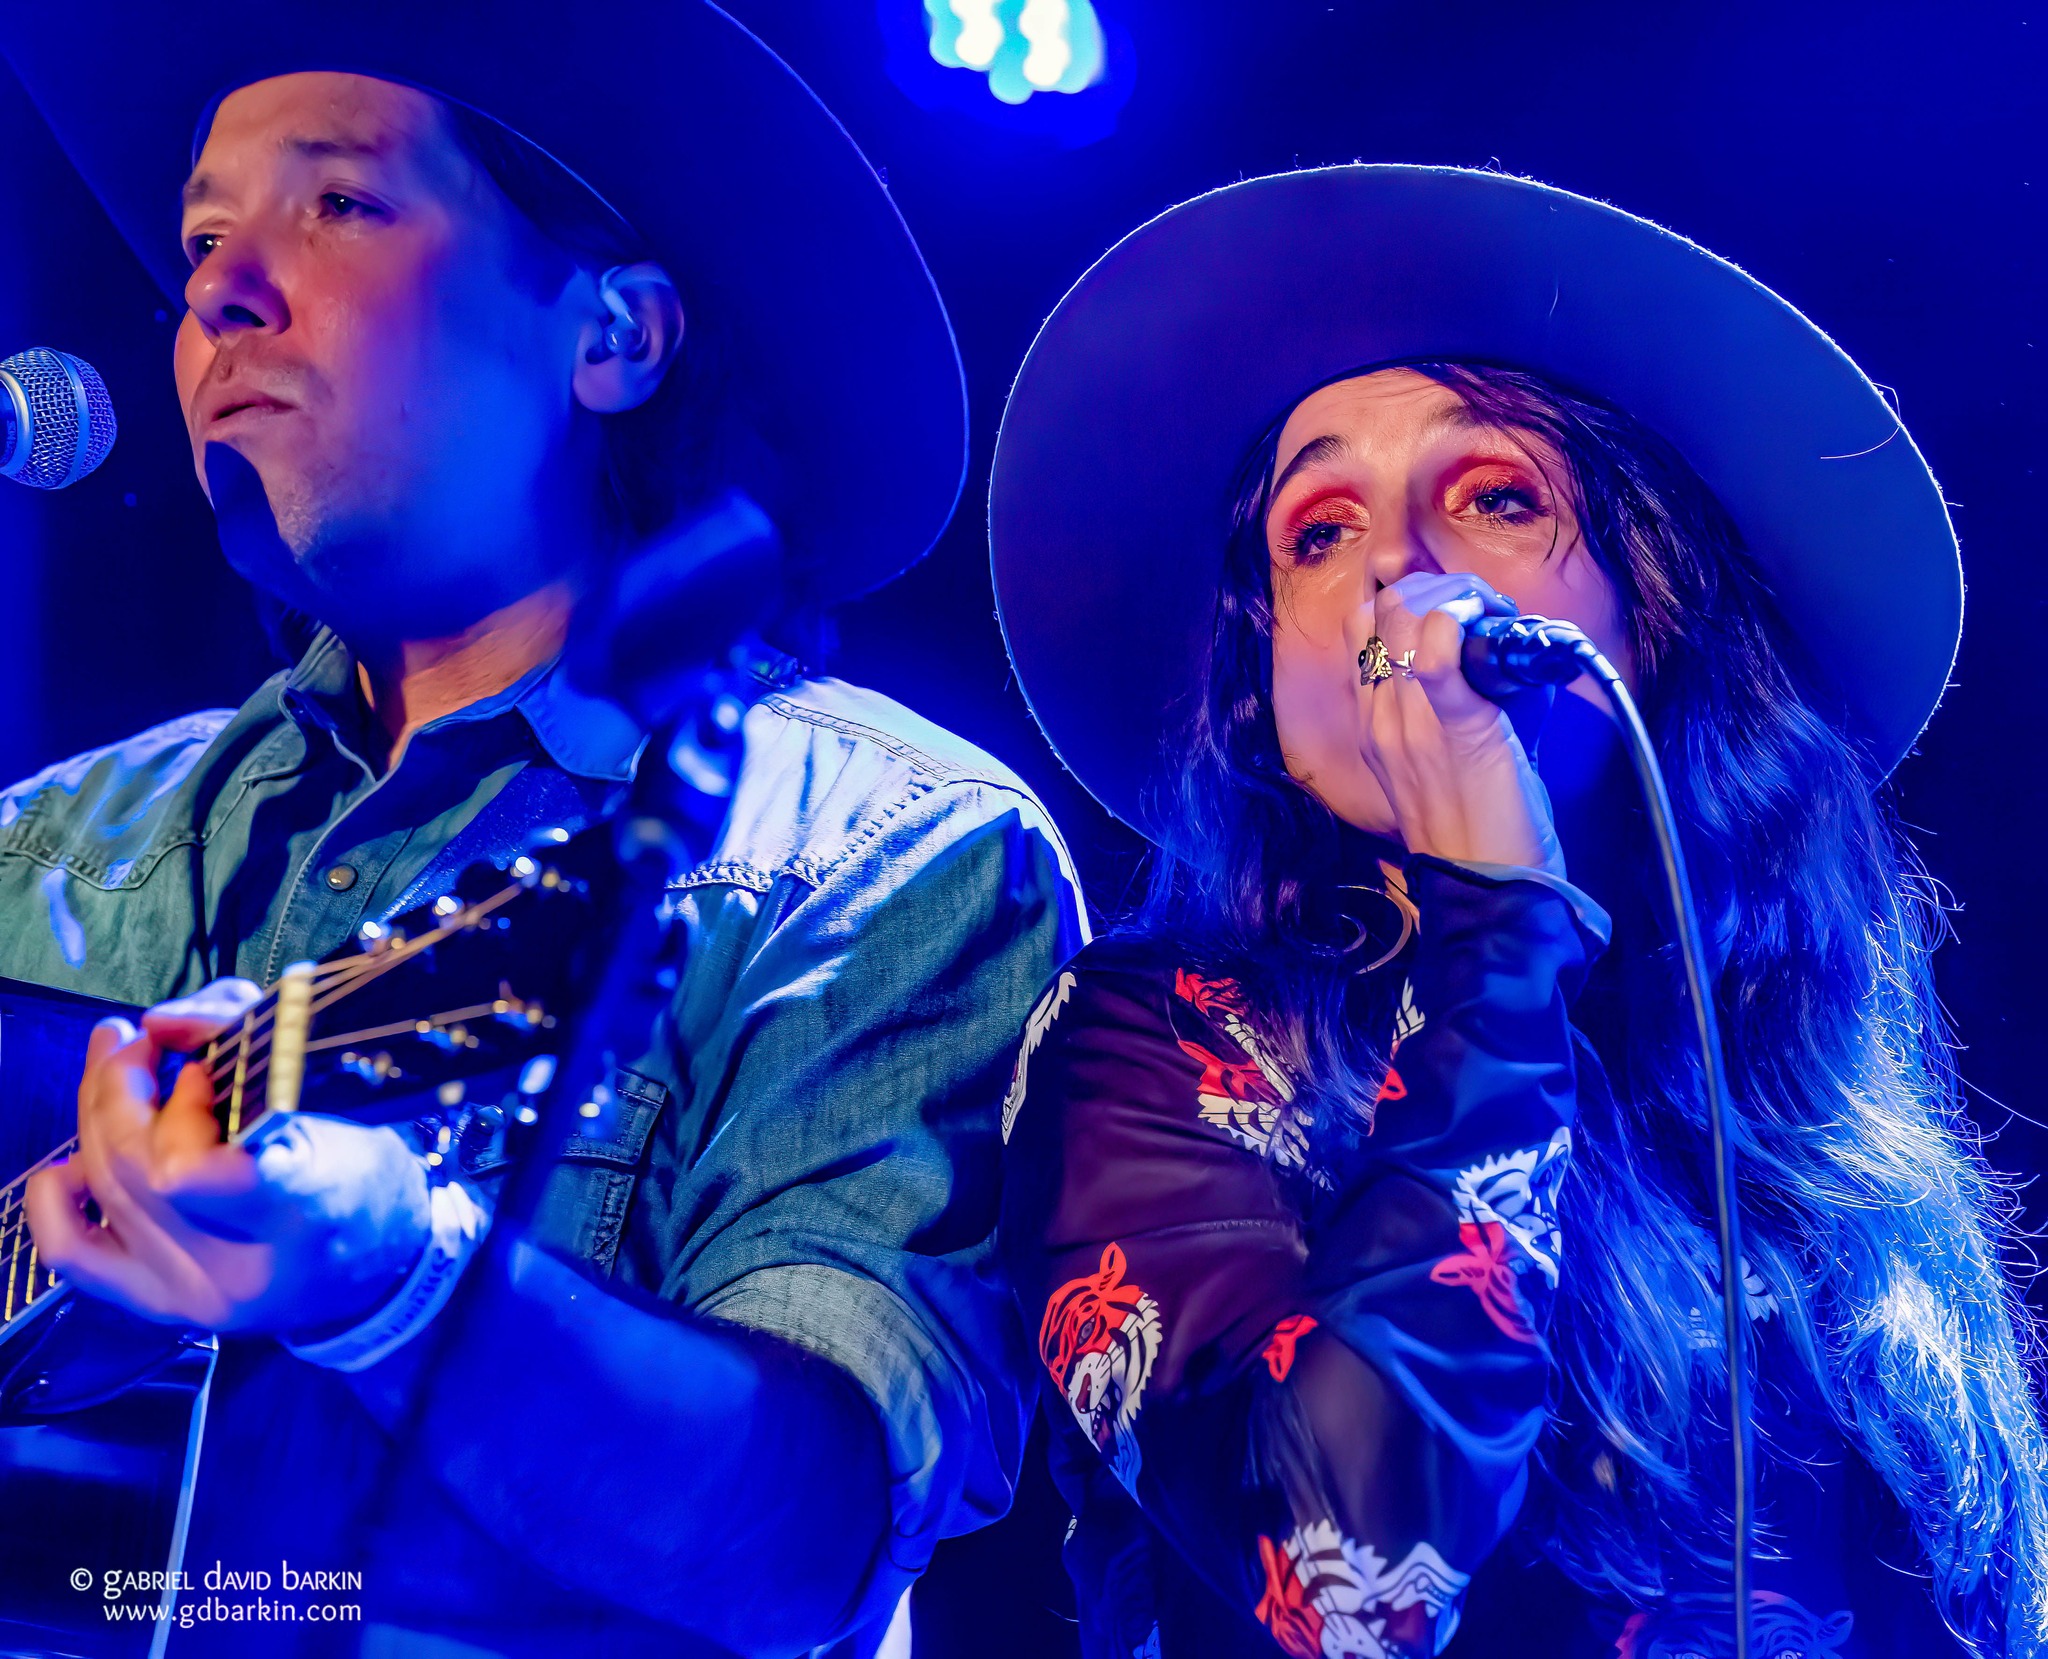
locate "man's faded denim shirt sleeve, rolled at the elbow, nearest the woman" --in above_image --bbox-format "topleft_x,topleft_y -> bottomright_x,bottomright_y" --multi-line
645,780 -> 1083,1624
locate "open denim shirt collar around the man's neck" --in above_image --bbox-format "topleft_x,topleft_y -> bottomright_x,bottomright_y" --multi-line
281,629 -> 647,782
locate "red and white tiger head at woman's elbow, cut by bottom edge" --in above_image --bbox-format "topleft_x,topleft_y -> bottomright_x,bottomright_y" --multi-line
1253,1520 -> 1466,1659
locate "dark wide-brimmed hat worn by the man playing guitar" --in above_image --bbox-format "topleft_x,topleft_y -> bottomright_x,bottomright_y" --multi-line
0,0 -> 967,598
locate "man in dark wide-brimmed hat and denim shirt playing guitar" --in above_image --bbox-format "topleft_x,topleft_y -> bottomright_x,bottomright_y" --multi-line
0,0 -> 1081,1653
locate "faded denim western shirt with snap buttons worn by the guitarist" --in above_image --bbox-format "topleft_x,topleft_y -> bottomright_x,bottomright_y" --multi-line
0,635 -> 1085,1622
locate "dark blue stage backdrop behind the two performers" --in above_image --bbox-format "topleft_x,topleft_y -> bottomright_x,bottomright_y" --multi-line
0,0 -> 2048,1655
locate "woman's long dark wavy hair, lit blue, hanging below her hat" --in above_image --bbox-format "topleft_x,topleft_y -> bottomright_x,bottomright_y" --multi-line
1139,363 -> 2048,1655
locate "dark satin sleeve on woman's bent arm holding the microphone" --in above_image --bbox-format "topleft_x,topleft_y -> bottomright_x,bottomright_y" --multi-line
1001,858 -> 1604,1659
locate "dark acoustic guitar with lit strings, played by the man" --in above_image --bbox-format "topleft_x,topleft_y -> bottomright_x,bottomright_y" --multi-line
0,846 -> 602,1659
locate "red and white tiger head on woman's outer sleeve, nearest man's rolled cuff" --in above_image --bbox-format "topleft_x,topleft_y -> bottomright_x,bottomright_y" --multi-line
1038,1243 -> 1165,1489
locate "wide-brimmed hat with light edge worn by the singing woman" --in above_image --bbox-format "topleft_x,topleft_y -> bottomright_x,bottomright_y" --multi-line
989,166 -> 1962,838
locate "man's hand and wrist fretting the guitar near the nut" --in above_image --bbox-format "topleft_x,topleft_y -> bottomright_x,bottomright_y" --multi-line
25,979 -> 428,1333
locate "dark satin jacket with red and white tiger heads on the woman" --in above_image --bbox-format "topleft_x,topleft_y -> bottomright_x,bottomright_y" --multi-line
999,858 -> 1958,1659
